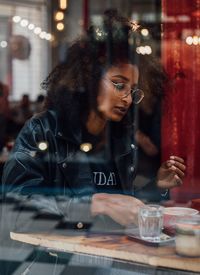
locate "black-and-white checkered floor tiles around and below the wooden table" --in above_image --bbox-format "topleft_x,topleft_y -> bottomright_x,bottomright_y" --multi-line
0,202 -> 197,275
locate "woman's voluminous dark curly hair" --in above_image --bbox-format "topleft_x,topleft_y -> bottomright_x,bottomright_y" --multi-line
42,10 -> 168,126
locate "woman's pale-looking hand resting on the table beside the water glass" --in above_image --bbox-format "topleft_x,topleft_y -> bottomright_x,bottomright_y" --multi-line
91,193 -> 144,226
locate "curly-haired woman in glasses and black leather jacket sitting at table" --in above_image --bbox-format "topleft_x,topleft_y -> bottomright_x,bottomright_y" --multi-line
3,10 -> 185,232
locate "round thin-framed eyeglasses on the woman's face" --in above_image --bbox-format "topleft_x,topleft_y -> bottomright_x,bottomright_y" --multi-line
106,78 -> 144,104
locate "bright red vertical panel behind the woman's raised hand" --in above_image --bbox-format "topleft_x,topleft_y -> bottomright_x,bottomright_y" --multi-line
162,0 -> 200,202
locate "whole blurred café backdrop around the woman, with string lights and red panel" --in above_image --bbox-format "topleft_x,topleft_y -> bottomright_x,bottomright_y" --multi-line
0,0 -> 200,209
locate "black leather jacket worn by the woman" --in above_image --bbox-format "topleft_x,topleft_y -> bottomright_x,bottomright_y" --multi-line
3,110 -> 138,229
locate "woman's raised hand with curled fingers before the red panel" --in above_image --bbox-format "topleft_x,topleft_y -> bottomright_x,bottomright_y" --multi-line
157,156 -> 186,189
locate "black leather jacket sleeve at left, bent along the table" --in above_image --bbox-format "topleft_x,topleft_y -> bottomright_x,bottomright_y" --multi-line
2,119 -> 92,233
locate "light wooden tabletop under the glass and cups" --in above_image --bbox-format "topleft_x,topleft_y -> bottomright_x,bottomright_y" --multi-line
10,232 -> 200,274
